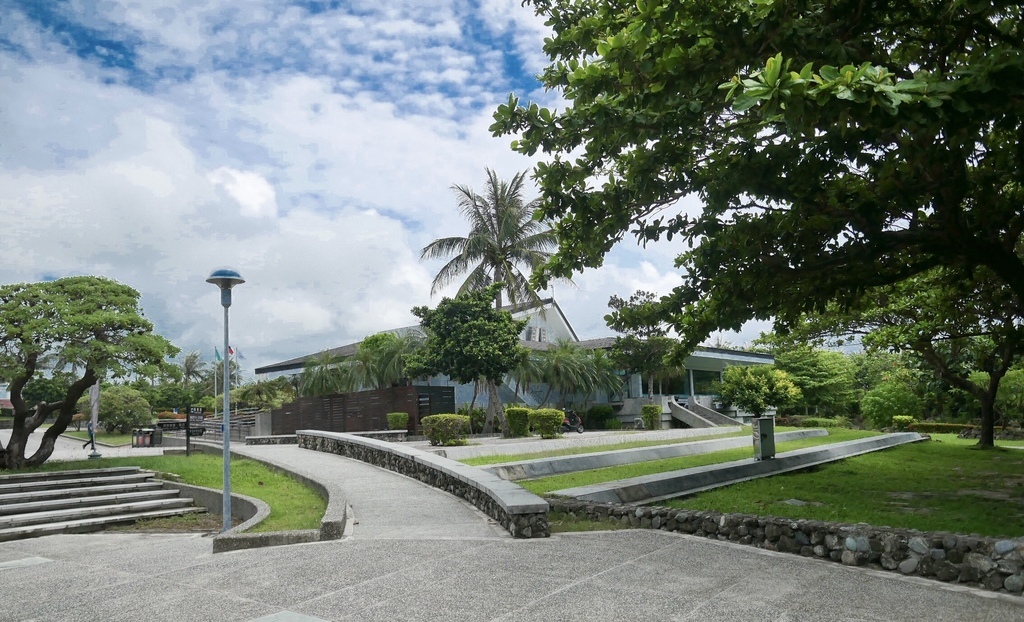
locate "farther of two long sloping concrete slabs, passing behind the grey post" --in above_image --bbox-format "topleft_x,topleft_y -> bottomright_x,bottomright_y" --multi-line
481,428 -> 828,481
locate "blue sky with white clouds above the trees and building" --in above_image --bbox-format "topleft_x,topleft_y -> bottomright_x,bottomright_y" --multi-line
0,0 -> 756,379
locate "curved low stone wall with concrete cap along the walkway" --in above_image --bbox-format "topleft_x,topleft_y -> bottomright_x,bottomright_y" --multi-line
296,430 -> 550,538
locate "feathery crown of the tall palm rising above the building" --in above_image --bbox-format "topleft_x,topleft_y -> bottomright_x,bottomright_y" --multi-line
420,168 -> 557,307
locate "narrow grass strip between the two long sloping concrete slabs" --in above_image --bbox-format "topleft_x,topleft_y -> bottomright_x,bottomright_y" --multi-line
518,428 -> 879,495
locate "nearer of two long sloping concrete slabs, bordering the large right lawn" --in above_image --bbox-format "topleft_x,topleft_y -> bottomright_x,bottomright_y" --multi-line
551,432 -> 925,503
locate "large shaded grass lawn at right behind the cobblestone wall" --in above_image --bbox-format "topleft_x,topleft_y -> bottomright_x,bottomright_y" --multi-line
663,434 -> 1024,538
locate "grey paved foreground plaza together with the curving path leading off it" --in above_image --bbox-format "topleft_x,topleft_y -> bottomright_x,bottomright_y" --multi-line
0,430 -> 1024,622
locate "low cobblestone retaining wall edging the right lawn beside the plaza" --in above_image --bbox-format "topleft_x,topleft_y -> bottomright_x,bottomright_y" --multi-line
548,499 -> 1024,594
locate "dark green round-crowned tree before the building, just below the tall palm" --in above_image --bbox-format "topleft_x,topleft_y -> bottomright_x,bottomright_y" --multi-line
410,283 -> 526,437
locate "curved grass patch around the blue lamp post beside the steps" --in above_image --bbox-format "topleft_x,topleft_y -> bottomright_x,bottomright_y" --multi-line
32,454 -> 327,532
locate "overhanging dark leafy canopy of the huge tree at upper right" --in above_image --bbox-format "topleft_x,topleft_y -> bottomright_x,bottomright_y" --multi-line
492,0 -> 1024,345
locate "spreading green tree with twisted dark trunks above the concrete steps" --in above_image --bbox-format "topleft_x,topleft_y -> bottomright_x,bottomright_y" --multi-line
0,277 -> 177,468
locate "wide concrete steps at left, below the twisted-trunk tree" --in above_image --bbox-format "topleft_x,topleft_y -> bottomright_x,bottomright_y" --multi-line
0,466 -> 206,542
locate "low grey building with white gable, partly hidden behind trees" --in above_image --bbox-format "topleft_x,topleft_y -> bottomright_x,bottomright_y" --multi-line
256,298 -> 774,426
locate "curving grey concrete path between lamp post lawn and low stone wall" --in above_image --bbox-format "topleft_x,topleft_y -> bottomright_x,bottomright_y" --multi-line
231,444 -> 511,539
